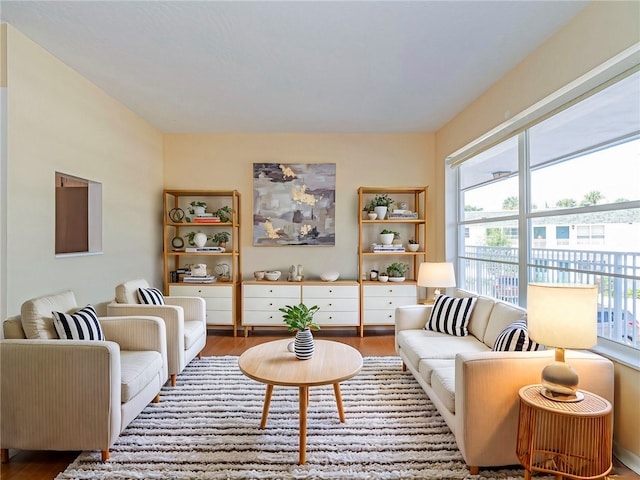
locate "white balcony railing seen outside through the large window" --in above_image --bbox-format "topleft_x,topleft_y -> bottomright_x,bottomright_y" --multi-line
460,246 -> 640,348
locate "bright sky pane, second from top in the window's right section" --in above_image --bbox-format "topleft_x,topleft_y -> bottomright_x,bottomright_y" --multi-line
531,139 -> 640,211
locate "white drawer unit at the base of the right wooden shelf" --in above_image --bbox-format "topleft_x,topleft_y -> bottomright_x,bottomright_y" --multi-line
362,283 -> 417,326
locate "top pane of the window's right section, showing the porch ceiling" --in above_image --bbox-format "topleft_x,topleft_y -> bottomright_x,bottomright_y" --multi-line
529,72 -> 640,170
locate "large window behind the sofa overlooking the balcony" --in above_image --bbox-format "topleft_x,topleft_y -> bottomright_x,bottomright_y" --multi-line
456,71 -> 640,349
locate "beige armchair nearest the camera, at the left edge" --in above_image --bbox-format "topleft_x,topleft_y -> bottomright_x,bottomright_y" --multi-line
0,291 -> 168,463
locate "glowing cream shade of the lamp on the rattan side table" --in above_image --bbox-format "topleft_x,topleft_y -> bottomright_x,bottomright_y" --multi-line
527,284 -> 598,348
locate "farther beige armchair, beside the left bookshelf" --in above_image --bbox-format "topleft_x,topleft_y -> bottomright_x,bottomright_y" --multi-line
107,280 -> 207,387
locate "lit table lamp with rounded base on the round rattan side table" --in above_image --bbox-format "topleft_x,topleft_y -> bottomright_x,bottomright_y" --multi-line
527,283 -> 598,402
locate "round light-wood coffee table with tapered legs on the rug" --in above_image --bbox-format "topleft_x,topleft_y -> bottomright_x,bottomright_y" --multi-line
238,339 -> 362,465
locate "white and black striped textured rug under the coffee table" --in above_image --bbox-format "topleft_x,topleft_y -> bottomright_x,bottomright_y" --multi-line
57,356 -> 543,479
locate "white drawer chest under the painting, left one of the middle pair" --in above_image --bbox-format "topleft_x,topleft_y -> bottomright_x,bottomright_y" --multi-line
242,281 -> 301,337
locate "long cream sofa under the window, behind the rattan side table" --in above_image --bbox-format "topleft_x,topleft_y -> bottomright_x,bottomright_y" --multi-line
395,290 -> 614,474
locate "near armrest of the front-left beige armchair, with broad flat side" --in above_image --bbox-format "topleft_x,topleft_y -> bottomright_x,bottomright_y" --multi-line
0,340 -> 122,450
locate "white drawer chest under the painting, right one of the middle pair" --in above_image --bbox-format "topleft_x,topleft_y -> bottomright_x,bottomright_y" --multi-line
302,282 -> 360,327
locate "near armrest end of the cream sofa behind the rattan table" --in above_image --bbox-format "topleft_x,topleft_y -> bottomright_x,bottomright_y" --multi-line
454,350 -> 614,467
